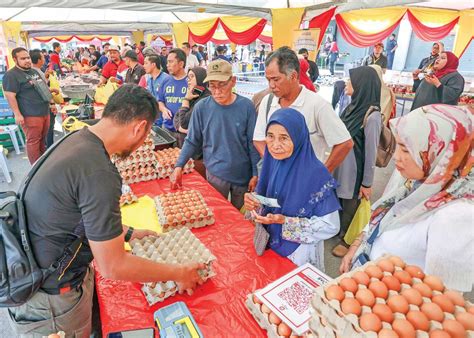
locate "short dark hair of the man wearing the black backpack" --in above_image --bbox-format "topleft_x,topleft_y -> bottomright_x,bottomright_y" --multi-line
102,84 -> 158,125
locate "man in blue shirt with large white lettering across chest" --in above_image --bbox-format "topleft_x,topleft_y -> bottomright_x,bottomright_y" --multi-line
158,48 -> 188,133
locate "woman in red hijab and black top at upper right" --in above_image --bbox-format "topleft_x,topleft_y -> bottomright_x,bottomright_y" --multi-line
411,52 -> 464,111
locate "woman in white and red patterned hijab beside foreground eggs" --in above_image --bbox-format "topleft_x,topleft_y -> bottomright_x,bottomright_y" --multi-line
340,104 -> 474,291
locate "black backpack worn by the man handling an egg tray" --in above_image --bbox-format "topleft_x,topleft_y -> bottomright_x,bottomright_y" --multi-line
0,133 -> 84,307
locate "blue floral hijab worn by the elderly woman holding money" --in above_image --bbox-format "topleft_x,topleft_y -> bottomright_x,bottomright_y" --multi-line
257,108 -> 341,257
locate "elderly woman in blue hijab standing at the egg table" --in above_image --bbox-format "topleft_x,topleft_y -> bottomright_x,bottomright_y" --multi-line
245,108 -> 340,270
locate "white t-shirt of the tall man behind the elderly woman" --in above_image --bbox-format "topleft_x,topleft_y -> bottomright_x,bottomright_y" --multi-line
253,86 -> 351,163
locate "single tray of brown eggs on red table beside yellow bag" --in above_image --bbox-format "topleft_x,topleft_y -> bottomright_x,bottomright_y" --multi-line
155,190 -> 215,232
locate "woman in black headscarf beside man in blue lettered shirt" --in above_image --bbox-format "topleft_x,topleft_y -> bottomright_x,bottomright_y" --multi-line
173,67 -> 211,148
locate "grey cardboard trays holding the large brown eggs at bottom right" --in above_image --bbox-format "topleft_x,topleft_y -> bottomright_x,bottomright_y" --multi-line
309,256 -> 474,338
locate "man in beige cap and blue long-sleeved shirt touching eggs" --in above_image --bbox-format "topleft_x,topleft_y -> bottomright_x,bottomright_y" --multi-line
171,60 -> 260,210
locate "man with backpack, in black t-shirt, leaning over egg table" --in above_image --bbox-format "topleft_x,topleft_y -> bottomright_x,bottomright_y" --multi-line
8,85 -> 205,337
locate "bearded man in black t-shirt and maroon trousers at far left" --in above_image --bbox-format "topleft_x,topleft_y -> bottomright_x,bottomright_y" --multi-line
3,47 -> 50,164
